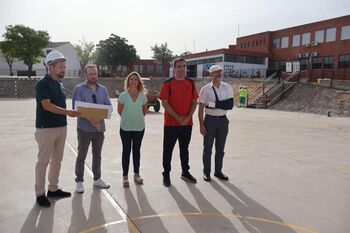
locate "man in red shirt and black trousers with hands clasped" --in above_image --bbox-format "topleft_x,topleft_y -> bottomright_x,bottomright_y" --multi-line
160,58 -> 198,187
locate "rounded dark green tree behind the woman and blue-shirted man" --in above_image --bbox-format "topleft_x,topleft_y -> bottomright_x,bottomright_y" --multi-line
96,34 -> 137,74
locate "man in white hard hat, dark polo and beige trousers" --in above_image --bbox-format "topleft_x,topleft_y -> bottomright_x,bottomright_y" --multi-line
35,50 -> 79,207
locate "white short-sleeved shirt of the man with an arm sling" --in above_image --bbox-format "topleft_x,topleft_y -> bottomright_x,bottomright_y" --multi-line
199,81 -> 233,116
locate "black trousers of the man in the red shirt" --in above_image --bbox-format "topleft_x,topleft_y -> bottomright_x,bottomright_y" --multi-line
163,126 -> 192,176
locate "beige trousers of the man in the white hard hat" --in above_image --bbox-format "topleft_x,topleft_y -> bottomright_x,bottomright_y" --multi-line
35,126 -> 67,196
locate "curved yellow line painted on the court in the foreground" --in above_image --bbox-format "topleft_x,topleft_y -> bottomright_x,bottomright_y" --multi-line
80,212 -> 319,233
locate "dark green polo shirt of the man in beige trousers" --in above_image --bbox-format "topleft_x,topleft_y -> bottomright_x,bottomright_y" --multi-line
35,74 -> 67,128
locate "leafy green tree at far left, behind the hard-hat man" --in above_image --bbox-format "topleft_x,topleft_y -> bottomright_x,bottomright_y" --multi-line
3,25 -> 50,77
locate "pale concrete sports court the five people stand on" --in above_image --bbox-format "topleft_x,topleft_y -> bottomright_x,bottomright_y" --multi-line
0,99 -> 350,233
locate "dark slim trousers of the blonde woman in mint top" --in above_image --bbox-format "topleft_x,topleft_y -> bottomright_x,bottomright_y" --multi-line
119,129 -> 145,176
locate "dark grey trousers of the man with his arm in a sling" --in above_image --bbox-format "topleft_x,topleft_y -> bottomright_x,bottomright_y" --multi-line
203,115 -> 229,175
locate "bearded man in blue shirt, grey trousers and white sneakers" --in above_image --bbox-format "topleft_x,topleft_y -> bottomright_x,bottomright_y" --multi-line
72,64 -> 111,193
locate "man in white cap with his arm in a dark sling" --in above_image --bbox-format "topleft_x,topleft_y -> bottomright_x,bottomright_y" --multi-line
198,65 -> 233,182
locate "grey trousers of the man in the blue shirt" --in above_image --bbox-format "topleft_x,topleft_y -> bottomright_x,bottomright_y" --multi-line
75,129 -> 105,182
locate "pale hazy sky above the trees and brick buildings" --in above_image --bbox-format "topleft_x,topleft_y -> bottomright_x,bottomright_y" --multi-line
0,0 -> 350,59
